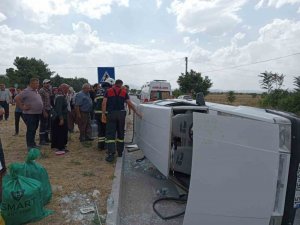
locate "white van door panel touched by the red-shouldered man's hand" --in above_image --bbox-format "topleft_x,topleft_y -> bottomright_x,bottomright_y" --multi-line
134,104 -> 172,177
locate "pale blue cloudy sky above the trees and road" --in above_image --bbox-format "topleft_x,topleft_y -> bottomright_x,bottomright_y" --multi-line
0,0 -> 300,91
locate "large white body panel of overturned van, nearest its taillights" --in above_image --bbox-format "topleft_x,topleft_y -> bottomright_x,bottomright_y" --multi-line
184,113 -> 289,225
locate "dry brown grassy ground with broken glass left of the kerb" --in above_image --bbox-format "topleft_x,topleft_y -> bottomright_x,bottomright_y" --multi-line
0,106 -> 115,225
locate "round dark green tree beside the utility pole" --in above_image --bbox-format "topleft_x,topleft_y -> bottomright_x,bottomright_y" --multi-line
177,70 -> 212,97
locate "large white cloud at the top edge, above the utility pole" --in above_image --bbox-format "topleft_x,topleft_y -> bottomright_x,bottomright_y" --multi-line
168,0 -> 247,35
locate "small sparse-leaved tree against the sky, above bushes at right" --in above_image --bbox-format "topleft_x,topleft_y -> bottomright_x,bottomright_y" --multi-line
258,71 -> 285,94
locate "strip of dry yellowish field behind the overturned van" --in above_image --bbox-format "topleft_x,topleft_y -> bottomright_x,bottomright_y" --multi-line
205,93 -> 260,107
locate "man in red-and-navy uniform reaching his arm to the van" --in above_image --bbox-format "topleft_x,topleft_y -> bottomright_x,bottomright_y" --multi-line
101,80 -> 142,162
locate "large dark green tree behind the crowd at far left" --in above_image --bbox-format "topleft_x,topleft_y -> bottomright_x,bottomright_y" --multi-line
6,57 -> 54,88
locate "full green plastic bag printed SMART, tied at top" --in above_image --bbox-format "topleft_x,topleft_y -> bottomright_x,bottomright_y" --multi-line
1,163 -> 51,225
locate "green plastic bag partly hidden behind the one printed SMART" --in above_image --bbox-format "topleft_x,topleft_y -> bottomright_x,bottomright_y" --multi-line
17,148 -> 52,205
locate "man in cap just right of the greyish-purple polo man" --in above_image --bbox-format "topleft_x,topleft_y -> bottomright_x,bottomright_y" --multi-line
39,79 -> 51,145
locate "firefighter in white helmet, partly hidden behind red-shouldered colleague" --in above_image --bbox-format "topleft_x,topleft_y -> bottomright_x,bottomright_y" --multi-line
94,78 -> 115,150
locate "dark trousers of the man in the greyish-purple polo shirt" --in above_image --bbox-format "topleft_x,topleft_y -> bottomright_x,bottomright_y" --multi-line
23,114 -> 40,148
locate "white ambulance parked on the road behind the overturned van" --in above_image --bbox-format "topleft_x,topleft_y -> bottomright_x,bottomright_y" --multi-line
141,80 -> 172,103
